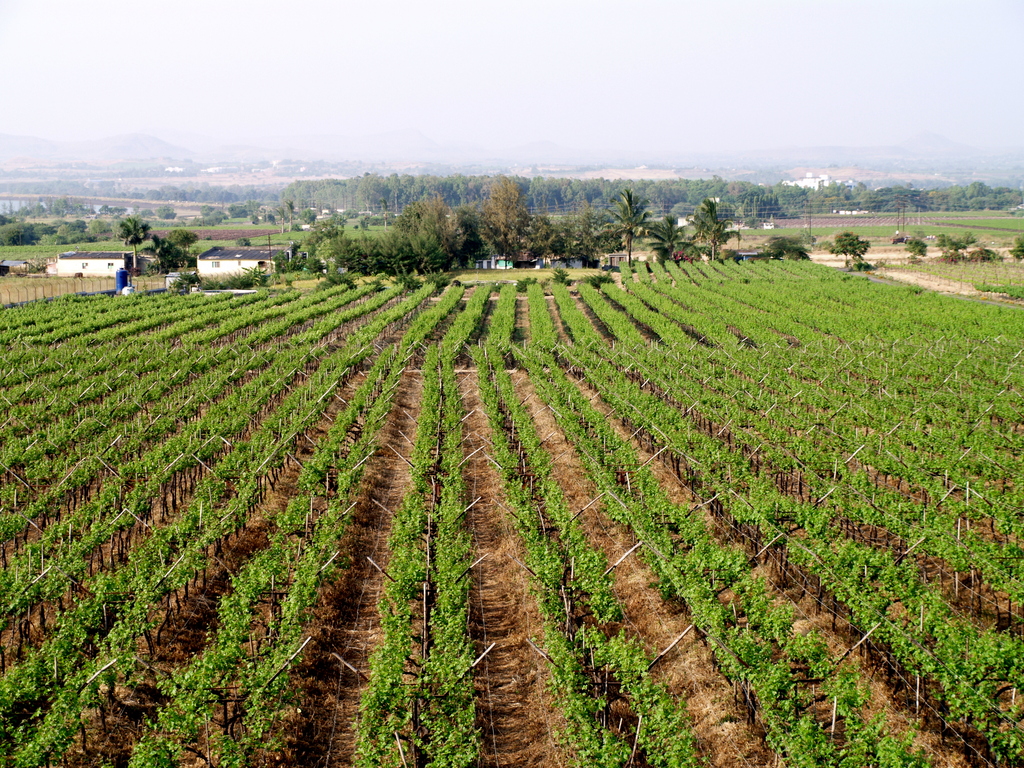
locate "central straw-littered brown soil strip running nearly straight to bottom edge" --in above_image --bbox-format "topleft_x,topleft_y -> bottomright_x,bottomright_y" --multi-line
460,372 -> 565,768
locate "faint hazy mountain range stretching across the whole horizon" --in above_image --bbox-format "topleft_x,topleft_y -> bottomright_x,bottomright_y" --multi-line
0,130 -> 1024,181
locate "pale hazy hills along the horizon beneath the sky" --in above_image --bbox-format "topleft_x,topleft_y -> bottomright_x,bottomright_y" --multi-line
0,129 -> 1024,184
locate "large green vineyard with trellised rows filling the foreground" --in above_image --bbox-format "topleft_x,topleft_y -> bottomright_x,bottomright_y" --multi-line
0,262 -> 1024,768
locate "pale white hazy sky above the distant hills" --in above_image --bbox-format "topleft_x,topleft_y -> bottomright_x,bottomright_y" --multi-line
0,0 -> 1024,153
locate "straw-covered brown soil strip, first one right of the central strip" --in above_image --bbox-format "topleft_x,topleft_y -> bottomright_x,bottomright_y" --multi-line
514,375 -> 776,768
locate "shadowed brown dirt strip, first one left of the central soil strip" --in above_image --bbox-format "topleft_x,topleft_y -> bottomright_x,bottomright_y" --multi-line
278,372 -> 422,768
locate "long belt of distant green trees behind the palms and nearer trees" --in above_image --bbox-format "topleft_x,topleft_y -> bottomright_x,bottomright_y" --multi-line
282,173 -> 1021,220
